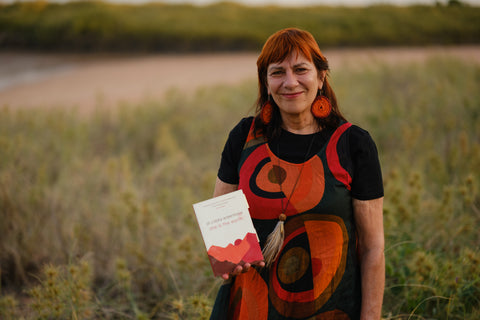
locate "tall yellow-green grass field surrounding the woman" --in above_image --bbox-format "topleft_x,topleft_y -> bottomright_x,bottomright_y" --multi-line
0,58 -> 480,320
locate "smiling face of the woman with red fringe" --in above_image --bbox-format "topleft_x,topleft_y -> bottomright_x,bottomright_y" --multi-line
267,53 -> 326,117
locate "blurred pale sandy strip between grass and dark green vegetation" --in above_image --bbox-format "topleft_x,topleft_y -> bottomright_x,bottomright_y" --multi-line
0,46 -> 480,112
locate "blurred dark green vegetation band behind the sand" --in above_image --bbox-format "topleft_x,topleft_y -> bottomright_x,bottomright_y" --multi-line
0,0 -> 480,52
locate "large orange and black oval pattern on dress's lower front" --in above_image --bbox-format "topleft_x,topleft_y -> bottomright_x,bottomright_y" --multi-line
269,214 -> 348,317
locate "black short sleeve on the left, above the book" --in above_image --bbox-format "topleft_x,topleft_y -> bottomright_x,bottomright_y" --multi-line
218,117 -> 253,184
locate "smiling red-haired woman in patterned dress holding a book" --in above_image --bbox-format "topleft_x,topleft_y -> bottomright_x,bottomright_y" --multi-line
212,28 -> 385,319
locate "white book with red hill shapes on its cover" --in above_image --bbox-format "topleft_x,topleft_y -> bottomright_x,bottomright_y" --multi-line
193,190 -> 263,276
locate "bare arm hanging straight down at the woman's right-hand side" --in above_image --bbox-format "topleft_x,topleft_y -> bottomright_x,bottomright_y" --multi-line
353,197 -> 385,320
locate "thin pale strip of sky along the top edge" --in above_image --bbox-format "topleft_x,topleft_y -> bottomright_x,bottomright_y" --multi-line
0,0 -> 480,6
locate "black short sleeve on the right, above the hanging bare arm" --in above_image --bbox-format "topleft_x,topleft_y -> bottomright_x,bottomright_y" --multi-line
342,126 -> 384,200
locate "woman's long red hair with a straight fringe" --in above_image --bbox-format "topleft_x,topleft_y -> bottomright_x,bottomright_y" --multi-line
255,28 -> 345,138
